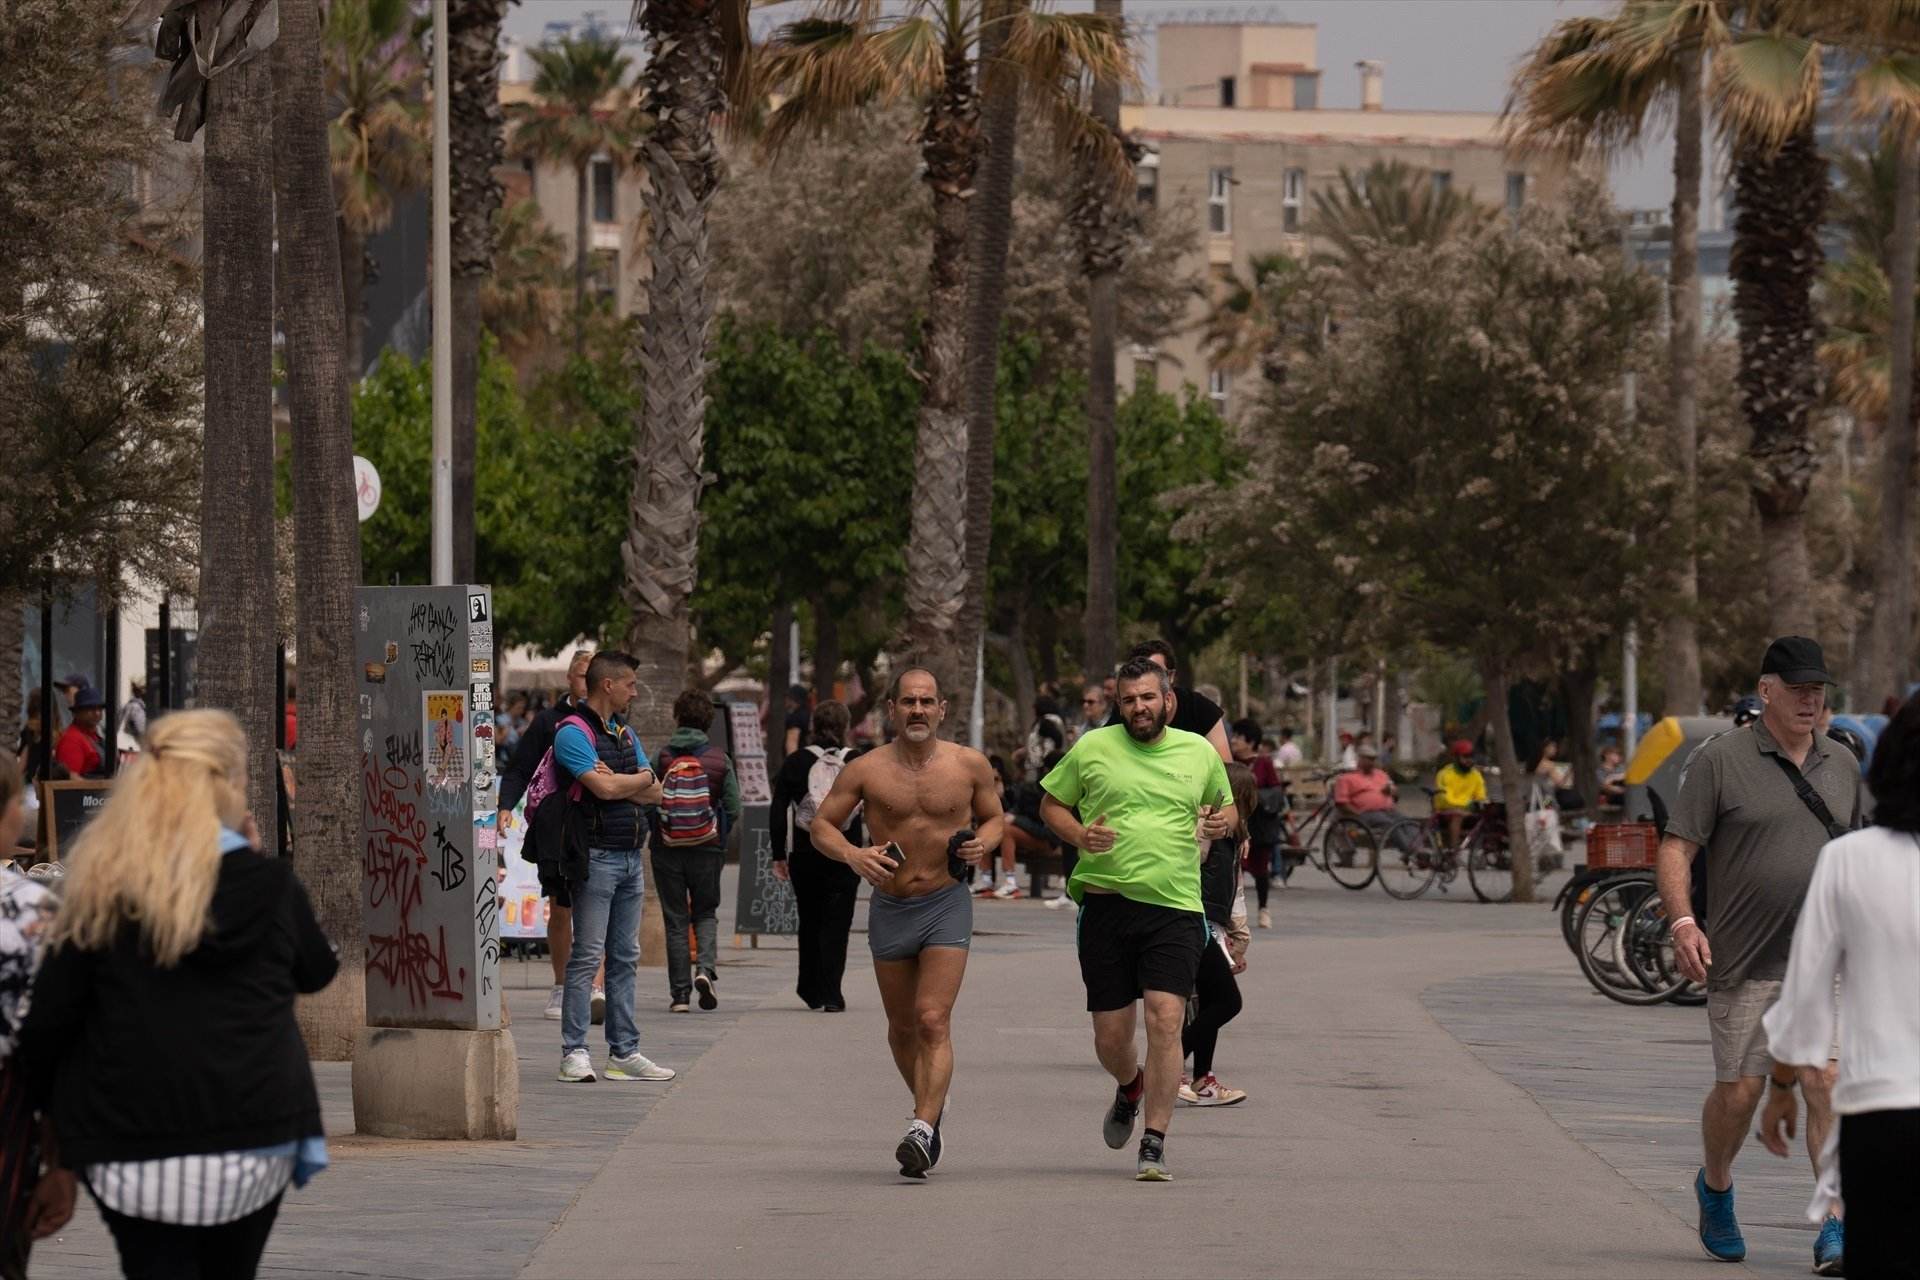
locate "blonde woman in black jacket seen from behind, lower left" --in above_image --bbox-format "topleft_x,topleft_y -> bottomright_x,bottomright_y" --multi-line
19,710 -> 338,1280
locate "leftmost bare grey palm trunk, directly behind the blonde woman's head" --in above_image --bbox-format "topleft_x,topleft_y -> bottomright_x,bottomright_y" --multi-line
196,58 -> 280,827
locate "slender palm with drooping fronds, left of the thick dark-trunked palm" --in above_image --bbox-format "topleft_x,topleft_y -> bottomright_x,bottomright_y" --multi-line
1507,0 -> 1730,716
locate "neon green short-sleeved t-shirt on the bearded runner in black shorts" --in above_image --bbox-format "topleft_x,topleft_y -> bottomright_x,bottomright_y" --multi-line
1041,725 -> 1233,912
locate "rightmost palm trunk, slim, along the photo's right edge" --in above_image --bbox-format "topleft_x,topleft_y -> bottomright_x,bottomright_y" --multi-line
1864,138 -> 1920,710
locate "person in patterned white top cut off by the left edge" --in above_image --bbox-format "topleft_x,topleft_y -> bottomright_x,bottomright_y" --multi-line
0,756 -> 73,1280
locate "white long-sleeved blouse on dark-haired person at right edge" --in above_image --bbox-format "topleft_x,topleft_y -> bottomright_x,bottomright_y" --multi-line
1764,827 -> 1920,1221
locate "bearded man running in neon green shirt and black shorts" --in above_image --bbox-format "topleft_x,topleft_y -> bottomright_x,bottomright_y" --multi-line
1041,658 -> 1235,1182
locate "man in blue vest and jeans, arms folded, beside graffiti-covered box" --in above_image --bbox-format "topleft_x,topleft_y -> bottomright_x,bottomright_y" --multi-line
553,651 -> 674,1084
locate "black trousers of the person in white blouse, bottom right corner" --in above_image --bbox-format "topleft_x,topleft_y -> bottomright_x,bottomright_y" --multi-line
1839,1109 -> 1920,1280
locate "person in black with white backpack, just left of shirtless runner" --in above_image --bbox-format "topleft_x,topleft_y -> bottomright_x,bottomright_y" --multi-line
768,700 -> 860,1013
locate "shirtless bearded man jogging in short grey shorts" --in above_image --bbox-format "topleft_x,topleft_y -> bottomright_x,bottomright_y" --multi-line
810,668 -> 1002,1178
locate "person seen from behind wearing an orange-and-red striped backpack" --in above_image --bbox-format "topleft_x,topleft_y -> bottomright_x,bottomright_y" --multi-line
653,689 -> 739,1013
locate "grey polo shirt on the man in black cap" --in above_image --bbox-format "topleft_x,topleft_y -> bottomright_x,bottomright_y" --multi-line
1667,720 -> 1864,990
